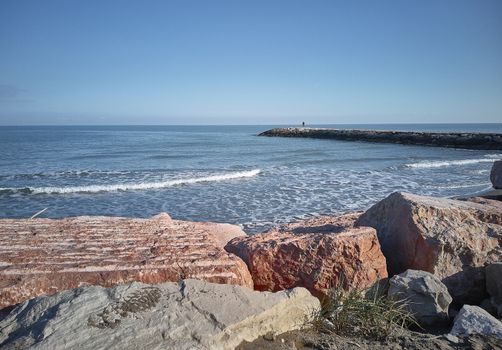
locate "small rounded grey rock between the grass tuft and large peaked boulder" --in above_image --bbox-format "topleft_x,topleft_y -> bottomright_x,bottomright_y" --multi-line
388,270 -> 452,326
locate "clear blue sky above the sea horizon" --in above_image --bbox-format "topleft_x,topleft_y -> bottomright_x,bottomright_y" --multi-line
0,0 -> 502,125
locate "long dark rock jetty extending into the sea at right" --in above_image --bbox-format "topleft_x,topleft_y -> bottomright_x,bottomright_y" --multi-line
258,128 -> 502,150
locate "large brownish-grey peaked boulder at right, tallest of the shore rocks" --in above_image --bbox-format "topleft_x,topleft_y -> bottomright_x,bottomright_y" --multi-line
357,193 -> 502,304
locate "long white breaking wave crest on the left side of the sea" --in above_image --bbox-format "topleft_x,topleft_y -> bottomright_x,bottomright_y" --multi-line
0,169 -> 261,194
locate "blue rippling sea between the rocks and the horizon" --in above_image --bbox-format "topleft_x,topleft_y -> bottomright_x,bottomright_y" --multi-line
0,124 -> 502,233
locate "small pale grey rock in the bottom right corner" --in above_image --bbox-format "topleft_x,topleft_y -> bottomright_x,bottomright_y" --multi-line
450,305 -> 502,339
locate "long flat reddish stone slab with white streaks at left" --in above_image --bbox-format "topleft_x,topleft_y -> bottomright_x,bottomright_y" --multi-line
0,214 -> 253,308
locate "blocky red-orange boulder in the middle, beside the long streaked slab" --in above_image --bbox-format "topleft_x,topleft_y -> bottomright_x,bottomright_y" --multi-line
225,214 -> 387,296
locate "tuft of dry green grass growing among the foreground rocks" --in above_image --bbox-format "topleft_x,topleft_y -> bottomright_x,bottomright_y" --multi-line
314,286 -> 418,338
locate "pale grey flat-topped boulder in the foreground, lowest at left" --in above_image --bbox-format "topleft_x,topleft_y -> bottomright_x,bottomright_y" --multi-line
0,280 -> 320,350
